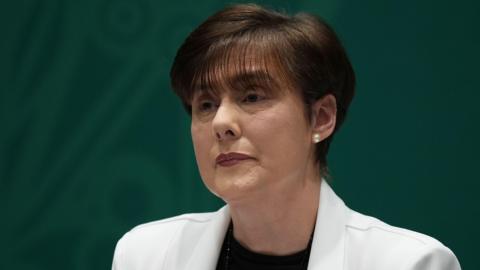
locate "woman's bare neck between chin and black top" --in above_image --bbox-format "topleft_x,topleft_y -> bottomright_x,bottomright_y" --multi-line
229,173 -> 321,256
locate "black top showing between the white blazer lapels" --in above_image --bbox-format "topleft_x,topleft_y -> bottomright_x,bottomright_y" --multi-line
217,227 -> 311,270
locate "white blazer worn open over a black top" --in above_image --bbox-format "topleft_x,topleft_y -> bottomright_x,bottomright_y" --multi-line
112,181 -> 460,270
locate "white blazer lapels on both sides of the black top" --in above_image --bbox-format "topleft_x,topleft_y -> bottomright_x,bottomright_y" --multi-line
186,179 -> 348,270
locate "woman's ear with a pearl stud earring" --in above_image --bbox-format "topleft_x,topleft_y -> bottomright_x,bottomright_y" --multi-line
312,94 -> 337,141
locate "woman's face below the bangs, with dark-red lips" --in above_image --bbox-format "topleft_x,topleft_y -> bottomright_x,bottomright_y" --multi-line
191,69 -> 316,202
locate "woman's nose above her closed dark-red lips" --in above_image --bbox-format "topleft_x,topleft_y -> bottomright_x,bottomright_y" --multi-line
212,101 -> 241,141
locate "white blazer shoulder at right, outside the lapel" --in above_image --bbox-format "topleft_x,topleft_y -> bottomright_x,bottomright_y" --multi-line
345,211 -> 460,270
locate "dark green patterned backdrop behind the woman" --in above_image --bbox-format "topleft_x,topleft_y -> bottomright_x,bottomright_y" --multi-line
0,0 -> 480,270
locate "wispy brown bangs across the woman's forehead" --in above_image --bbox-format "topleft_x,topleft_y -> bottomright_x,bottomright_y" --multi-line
176,33 -> 290,106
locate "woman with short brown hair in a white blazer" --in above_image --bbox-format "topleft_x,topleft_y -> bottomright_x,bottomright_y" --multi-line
113,2 -> 460,270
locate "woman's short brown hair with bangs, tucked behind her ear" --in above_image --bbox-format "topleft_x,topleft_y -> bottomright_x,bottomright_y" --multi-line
170,4 -> 355,176
